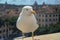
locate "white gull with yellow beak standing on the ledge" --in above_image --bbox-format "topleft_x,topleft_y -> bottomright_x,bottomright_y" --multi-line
16,6 -> 38,40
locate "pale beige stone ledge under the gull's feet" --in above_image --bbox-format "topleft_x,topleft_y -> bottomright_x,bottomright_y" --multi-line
14,33 -> 60,40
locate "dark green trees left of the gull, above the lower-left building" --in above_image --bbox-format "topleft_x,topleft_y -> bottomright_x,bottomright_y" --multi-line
0,16 -> 18,25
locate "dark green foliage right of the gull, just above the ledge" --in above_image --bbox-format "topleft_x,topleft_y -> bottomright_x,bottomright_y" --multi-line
35,23 -> 60,35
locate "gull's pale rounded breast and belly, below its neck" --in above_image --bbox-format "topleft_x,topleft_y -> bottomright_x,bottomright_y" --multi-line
17,16 -> 38,32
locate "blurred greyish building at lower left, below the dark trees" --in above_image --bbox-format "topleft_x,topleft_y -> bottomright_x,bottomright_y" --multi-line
0,24 -> 14,40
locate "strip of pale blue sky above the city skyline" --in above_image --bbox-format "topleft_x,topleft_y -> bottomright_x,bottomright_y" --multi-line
0,0 -> 60,5
